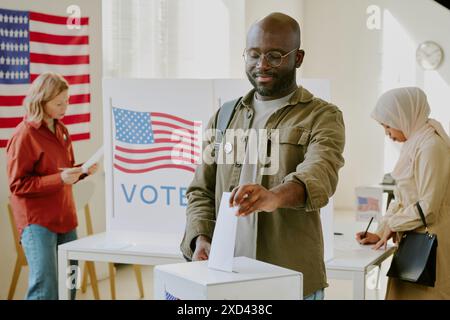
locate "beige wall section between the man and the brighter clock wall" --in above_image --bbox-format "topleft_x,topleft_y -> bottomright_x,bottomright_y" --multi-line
303,0 -> 383,209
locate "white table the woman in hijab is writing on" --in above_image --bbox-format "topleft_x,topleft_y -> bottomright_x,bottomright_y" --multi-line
325,237 -> 395,300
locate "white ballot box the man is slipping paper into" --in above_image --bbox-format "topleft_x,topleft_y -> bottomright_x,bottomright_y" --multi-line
153,257 -> 303,300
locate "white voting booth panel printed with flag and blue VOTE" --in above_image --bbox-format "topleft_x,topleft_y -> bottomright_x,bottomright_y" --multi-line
103,79 -> 213,240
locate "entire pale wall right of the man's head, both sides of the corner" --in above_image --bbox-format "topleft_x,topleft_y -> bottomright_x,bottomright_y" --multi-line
303,0 -> 450,209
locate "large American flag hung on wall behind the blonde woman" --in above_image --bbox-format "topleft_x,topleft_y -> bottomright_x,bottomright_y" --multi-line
0,9 -> 90,148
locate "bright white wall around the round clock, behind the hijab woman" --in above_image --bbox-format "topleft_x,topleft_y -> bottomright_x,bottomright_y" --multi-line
383,0 -> 450,172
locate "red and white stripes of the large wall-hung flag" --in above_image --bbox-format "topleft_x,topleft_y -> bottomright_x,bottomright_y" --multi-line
0,12 -> 91,148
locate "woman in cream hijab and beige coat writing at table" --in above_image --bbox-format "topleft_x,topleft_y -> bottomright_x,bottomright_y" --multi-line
356,87 -> 450,300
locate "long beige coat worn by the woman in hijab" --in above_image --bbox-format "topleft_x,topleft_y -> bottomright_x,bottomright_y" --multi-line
377,135 -> 450,300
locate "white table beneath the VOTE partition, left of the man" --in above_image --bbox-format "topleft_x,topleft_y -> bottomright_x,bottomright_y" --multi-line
58,231 -> 185,300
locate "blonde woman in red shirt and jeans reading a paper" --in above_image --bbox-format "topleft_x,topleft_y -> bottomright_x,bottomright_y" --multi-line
6,73 -> 97,300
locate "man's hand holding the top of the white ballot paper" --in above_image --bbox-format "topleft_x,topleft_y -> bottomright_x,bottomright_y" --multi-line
230,184 -> 279,217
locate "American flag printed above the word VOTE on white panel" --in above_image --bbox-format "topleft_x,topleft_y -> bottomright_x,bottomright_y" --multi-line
113,108 -> 201,174
